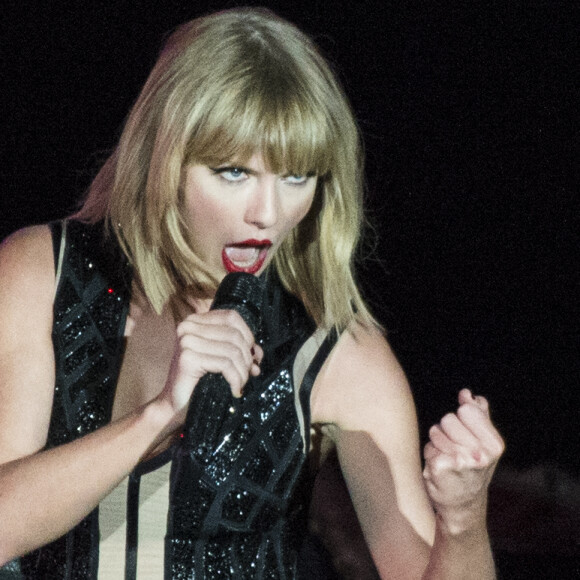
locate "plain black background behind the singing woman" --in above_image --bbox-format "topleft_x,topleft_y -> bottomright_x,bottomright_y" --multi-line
0,0 -> 580,578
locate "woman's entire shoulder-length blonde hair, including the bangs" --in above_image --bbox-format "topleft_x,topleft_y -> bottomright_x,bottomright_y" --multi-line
75,8 -> 373,330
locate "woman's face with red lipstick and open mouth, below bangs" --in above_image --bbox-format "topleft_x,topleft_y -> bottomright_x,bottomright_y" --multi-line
185,155 -> 316,280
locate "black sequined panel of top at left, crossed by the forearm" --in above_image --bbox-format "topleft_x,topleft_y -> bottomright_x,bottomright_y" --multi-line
20,221 -> 131,580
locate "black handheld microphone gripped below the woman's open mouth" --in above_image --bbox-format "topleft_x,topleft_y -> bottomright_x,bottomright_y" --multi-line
182,272 -> 263,450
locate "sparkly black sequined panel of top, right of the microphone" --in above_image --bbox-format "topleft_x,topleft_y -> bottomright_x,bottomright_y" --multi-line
165,274 -> 314,580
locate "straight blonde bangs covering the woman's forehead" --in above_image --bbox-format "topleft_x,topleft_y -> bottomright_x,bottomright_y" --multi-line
186,65 -> 336,175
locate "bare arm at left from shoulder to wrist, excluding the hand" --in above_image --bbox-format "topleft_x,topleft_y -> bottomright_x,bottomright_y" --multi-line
0,226 -> 178,563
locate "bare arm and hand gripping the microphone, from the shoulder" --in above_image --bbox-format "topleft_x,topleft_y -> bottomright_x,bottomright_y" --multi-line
0,226 -> 261,564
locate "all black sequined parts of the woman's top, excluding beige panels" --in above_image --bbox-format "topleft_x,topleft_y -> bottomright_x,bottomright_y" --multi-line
20,221 -> 336,580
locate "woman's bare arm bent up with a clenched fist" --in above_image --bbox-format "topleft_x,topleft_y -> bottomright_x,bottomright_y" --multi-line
312,328 -> 503,580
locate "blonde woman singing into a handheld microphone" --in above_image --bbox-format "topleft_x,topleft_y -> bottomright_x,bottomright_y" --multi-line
0,9 -> 503,580
